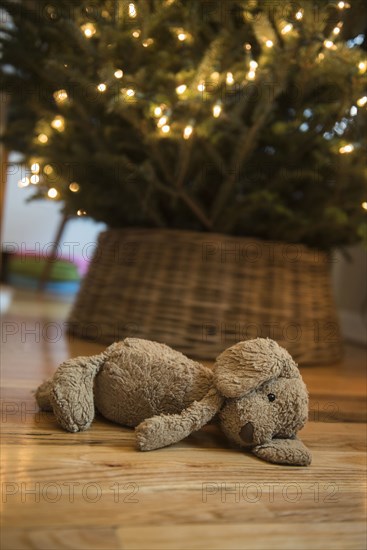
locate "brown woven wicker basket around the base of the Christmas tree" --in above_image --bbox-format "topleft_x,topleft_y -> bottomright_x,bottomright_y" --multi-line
69,229 -> 342,364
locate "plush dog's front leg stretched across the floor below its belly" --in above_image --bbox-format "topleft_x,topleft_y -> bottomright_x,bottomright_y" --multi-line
135,388 -> 224,451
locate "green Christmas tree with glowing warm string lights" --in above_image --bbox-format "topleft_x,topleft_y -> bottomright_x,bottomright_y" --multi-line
0,0 -> 367,250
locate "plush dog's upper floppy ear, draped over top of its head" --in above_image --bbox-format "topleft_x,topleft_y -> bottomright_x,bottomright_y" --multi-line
214,338 -> 300,397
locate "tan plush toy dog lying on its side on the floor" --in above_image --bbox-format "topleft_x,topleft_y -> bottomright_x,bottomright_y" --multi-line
36,338 -> 311,466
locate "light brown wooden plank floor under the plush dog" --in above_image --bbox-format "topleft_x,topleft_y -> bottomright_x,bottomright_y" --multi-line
1,295 -> 366,550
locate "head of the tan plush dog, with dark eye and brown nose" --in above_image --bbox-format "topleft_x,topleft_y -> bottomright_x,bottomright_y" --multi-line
214,338 -> 310,463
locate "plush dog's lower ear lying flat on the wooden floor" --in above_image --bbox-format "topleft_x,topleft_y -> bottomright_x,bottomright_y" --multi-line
252,438 -> 312,466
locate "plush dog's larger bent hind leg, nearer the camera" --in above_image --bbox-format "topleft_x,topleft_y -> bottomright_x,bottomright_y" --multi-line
51,353 -> 105,432
